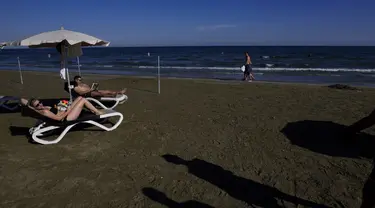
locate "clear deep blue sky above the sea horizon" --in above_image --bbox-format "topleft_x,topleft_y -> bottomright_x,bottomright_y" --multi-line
0,0 -> 375,46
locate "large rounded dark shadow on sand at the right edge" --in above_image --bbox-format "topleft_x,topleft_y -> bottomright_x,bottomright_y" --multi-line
281,120 -> 375,159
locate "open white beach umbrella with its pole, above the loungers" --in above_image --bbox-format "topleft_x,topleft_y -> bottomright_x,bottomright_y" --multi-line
3,27 -> 110,101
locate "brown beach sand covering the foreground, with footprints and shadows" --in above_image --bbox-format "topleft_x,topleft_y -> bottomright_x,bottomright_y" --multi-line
0,71 -> 375,208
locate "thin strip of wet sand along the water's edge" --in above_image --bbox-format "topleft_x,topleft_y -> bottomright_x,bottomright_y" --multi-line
0,69 -> 375,89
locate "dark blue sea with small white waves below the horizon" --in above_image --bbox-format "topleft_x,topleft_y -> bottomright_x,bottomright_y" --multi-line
0,46 -> 375,86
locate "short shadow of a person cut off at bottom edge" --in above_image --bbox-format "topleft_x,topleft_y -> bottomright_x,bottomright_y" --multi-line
142,187 -> 214,208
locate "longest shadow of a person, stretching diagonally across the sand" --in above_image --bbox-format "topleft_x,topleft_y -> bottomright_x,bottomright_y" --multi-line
162,155 -> 327,207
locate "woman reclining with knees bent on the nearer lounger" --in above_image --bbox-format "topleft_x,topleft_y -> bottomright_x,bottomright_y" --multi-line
21,97 -> 104,121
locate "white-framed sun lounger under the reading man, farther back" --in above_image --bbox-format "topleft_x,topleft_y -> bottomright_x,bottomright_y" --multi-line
64,82 -> 128,109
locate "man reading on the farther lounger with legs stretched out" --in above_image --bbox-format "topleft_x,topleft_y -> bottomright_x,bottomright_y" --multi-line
74,76 -> 126,97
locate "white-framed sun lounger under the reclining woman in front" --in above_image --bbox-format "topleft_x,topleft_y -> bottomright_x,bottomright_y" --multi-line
29,109 -> 124,144
